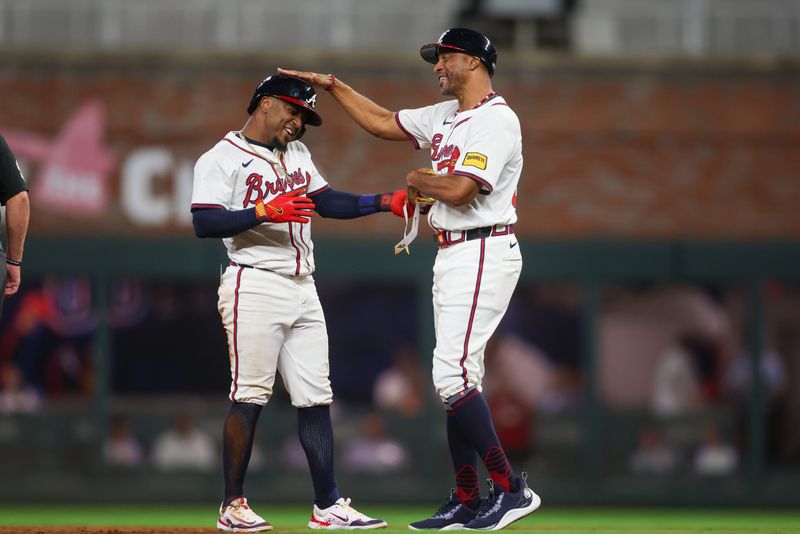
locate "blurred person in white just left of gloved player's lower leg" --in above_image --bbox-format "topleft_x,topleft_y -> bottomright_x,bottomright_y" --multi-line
153,413 -> 217,472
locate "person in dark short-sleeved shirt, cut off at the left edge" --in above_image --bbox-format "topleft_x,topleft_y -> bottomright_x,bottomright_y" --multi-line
0,136 -> 30,313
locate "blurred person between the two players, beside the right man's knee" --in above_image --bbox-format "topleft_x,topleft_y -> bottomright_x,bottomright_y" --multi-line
372,345 -> 432,417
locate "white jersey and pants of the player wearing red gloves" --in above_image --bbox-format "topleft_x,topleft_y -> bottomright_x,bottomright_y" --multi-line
192,132 -> 333,407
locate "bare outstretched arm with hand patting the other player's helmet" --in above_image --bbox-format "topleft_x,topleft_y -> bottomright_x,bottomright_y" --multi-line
278,68 -> 408,141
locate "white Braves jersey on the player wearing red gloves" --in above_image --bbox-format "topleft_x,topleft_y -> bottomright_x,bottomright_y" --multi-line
192,132 -> 328,276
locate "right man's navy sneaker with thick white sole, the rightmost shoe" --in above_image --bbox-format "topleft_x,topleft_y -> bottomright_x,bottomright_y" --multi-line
464,473 -> 542,530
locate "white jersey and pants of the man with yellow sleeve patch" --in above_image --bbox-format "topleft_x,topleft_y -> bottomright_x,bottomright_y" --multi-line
395,93 -> 522,402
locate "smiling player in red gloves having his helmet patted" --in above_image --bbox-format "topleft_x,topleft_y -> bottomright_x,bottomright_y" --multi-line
192,75 -> 406,532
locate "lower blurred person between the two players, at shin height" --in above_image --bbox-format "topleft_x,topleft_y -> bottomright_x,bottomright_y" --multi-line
342,413 -> 411,474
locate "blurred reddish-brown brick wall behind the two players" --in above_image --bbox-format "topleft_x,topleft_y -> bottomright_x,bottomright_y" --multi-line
0,57 -> 800,239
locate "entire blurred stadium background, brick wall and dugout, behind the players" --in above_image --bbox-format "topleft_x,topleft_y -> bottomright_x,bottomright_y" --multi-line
0,0 -> 800,506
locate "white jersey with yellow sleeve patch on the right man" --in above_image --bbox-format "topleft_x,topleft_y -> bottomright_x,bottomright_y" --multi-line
397,95 -> 522,230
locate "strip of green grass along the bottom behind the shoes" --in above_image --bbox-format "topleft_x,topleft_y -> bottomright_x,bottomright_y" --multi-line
0,504 -> 800,534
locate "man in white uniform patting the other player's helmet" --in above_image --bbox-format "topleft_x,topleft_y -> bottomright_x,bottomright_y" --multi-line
278,28 -> 541,530
